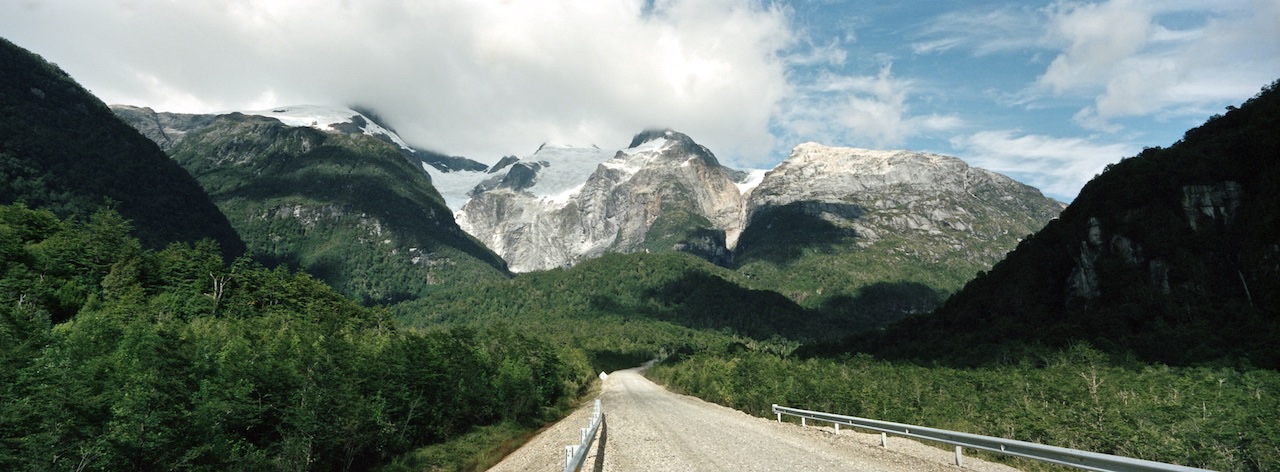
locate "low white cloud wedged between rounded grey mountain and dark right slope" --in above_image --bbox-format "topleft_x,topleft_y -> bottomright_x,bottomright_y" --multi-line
951,129 -> 1139,201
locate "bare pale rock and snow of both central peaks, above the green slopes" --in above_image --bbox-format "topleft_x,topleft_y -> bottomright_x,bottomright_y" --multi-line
455,130 -> 1061,276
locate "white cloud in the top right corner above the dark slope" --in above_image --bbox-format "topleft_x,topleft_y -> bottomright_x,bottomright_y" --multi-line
1037,0 -> 1280,132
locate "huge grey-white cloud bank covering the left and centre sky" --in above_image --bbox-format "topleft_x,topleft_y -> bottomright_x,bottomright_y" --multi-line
0,0 -> 793,161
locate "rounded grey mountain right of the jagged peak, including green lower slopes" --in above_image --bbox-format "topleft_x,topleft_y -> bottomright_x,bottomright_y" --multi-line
735,143 -> 1062,326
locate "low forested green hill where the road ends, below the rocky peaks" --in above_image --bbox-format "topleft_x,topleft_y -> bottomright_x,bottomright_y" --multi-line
396,253 -> 820,370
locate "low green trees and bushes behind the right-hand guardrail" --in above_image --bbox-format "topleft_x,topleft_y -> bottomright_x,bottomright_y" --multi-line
649,344 -> 1280,471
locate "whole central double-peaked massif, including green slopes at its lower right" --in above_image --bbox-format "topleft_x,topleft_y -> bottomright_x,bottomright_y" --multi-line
458,129 -> 1062,333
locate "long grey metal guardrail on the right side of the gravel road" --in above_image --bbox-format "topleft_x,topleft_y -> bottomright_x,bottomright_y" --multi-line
773,404 -> 1204,472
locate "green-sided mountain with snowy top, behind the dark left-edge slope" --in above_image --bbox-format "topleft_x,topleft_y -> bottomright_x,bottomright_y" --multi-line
115,106 -> 507,303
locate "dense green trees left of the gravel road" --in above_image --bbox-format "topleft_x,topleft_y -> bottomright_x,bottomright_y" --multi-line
0,206 -> 591,471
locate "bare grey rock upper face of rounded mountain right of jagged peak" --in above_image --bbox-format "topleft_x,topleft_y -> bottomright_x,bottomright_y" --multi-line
739,143 -> 1062,262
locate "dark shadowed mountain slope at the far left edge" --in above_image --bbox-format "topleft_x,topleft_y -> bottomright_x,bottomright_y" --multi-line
0,38 -> 244,257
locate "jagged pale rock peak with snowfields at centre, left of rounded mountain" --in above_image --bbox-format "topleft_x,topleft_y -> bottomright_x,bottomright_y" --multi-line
460,130 -> 742,271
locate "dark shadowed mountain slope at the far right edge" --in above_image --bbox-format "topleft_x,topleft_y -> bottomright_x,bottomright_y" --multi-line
829,82 -> 1280,368
